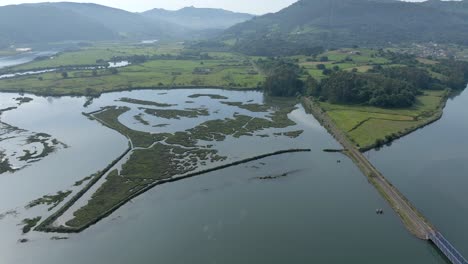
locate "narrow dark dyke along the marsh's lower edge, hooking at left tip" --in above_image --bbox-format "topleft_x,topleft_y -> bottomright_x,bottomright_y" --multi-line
36,149 -> 311,233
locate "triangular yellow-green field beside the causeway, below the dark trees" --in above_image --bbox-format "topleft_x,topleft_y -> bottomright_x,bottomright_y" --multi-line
320,91 -> 447,149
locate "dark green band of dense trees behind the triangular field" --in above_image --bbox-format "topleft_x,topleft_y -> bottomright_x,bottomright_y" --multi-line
257,55 -> 468,108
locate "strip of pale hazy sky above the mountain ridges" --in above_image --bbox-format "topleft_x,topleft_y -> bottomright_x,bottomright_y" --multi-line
0,0 -> 296,14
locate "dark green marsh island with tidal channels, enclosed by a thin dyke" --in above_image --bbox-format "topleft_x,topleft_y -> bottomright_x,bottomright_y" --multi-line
32,91 -> 310,232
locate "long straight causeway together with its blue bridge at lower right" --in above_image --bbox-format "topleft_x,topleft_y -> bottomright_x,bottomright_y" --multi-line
303,98 -> 468,264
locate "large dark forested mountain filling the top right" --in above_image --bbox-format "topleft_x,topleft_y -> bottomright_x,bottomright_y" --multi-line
222,0 -> 468,55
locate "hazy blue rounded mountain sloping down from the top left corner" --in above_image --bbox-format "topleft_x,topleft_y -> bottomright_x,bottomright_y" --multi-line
0,5 -> 116,46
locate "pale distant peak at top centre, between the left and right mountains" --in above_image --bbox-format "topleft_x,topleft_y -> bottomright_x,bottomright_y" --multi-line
142,7 -> 254,30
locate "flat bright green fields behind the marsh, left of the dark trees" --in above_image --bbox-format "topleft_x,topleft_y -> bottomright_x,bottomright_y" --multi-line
0,55 -> 264,95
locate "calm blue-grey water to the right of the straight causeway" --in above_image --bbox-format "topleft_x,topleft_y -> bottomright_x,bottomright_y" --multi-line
369,87 -> 468,257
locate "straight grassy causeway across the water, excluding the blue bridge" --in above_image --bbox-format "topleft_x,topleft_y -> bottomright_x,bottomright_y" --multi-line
303,98 -> 434,240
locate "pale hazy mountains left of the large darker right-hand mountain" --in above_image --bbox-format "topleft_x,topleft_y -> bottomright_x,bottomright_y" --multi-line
0,2 -> 253,46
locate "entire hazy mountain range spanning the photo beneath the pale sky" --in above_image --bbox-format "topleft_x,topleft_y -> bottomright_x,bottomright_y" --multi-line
0,0 -> 468,52
